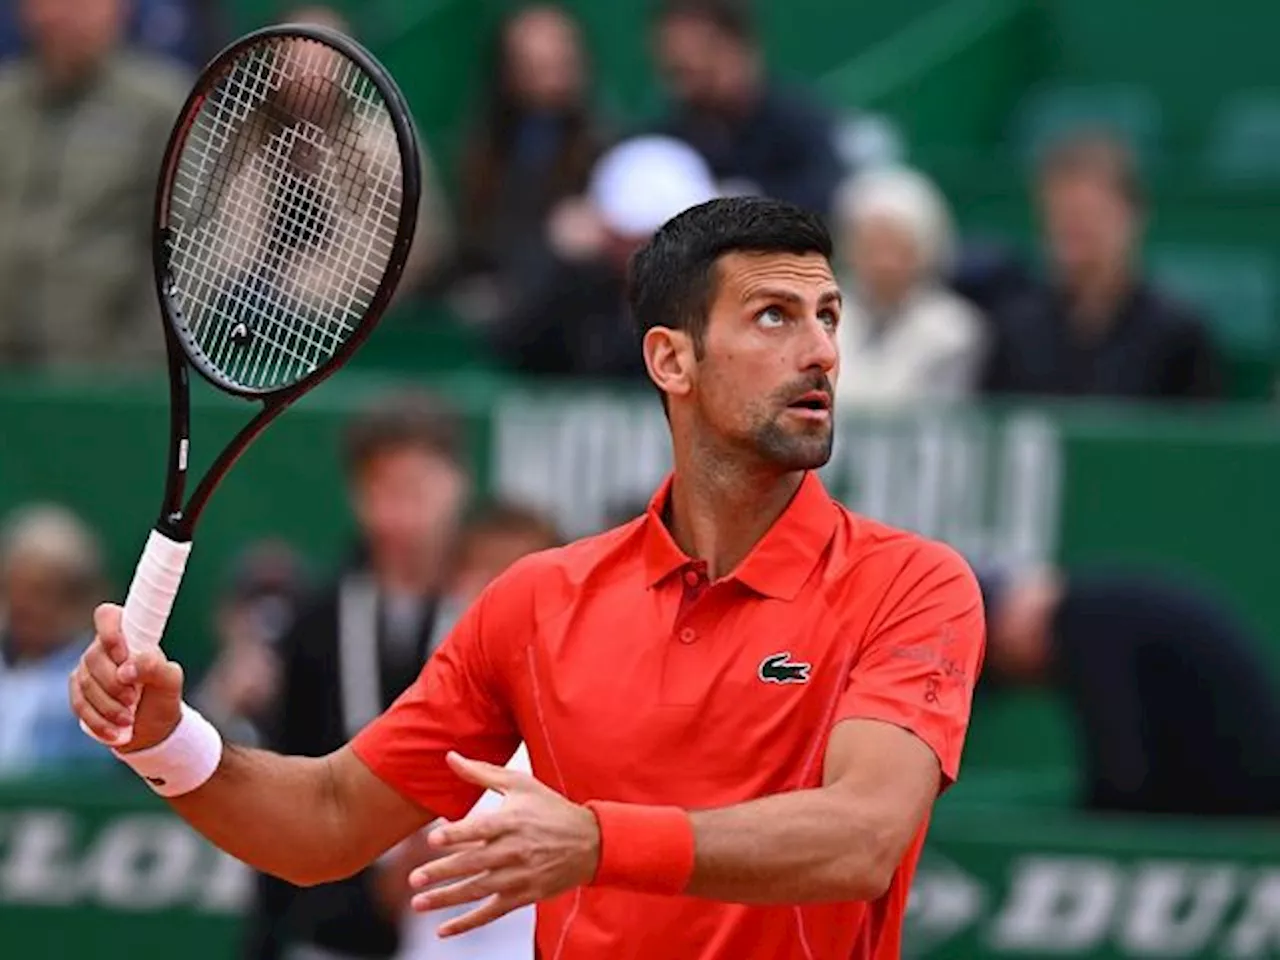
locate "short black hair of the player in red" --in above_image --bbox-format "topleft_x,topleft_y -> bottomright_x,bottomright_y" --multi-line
627,197 -> 832,351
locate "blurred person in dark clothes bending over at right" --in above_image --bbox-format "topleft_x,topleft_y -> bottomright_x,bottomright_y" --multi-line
979,571 -> 1280,817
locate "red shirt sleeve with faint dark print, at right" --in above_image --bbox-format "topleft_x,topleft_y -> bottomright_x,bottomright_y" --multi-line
836,541 -> 986,785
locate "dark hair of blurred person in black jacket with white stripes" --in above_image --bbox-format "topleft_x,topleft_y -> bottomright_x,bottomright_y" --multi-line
342,390 -> 467,477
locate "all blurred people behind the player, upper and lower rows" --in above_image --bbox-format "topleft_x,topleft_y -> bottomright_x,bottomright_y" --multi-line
0,0 -> 1280,960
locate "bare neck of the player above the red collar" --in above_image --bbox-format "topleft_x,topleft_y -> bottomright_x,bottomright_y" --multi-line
668,442 -> 804,580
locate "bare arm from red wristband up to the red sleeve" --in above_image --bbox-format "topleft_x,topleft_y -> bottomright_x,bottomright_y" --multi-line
686,719 -> 941,904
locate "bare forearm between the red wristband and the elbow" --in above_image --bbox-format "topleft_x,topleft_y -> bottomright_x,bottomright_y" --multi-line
686,787 -> 893,904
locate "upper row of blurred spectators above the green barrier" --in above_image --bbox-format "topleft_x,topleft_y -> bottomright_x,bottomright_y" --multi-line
0,0 -> 1225,407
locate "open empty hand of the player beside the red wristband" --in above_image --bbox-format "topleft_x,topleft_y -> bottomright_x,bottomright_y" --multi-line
410,753 -> 600,937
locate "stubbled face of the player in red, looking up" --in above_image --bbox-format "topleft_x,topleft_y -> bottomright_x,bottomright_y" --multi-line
690,253 -> 841,470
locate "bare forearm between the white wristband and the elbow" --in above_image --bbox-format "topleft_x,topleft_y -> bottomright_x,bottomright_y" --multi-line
169,744 -> 355,886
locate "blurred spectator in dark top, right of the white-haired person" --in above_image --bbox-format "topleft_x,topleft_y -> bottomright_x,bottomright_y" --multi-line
986,133 -> 1220,399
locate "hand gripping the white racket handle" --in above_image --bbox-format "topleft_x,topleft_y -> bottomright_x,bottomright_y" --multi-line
68,603 -> 182,753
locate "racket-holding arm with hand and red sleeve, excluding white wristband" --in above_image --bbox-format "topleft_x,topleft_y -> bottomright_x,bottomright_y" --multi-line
69,578 -> 520,886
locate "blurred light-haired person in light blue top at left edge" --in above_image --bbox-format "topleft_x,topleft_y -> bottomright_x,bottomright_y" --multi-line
0,504 -> 111,774
